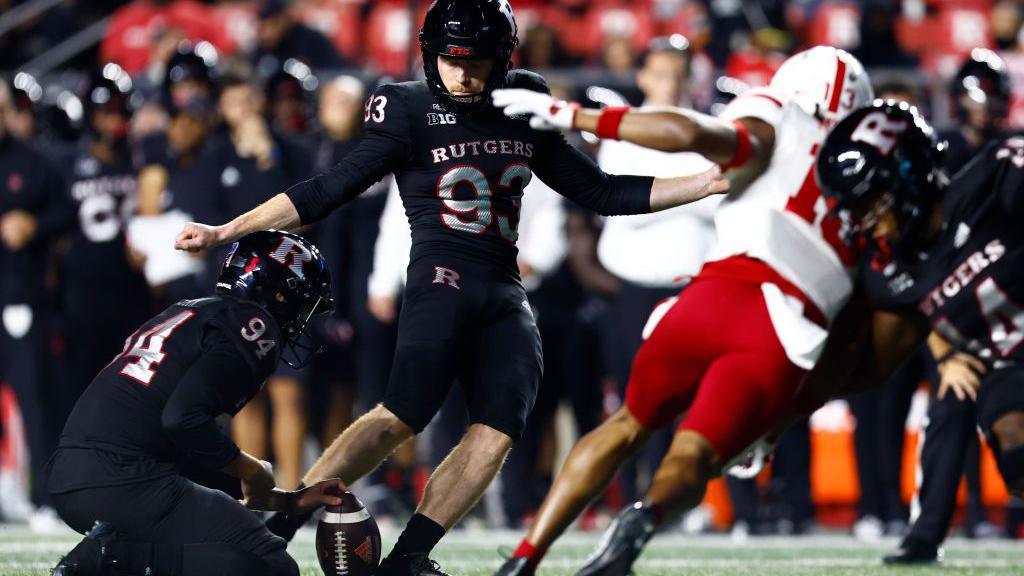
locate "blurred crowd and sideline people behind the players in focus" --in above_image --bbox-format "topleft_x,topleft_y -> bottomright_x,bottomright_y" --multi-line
0,0 -> 1024,538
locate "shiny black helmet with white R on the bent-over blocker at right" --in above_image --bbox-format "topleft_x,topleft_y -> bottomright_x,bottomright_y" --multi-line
816,100 -> 948,256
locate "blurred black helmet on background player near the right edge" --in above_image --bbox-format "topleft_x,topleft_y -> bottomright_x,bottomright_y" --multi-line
949,48 -> 1013,122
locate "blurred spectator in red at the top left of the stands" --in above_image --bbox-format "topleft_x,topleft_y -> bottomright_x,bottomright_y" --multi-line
99,0 -> 236,74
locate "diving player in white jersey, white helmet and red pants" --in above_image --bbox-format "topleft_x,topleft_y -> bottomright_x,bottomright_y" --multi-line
495,46 -> 871,576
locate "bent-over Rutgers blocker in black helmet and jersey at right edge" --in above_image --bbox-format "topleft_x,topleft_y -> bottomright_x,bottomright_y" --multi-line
808,100 -> 1024,504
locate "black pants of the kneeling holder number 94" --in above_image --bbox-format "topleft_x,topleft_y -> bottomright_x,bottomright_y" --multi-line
52,454 -> 299,576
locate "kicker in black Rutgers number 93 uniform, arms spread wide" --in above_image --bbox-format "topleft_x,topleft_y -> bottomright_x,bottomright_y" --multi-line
176,0 -> 735,575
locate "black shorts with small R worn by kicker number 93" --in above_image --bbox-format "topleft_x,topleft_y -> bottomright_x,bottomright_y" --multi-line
384,256 -> 544,440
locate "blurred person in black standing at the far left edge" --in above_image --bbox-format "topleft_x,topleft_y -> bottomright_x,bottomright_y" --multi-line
0,77 -> 73,529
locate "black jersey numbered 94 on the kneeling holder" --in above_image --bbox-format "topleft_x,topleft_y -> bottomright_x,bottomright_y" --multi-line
60,296 -> 280,461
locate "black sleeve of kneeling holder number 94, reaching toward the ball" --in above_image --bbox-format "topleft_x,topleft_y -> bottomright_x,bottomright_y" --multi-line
161,337 -> 262,469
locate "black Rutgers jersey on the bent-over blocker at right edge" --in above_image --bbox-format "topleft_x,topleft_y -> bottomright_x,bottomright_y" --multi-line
863,137 -> 1024,367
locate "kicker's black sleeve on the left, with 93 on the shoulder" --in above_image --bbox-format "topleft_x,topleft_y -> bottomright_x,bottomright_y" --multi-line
285,85 -> 412,224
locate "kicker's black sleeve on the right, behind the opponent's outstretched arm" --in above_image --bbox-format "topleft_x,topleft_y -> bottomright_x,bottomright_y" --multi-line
529,134 -> 654,216
